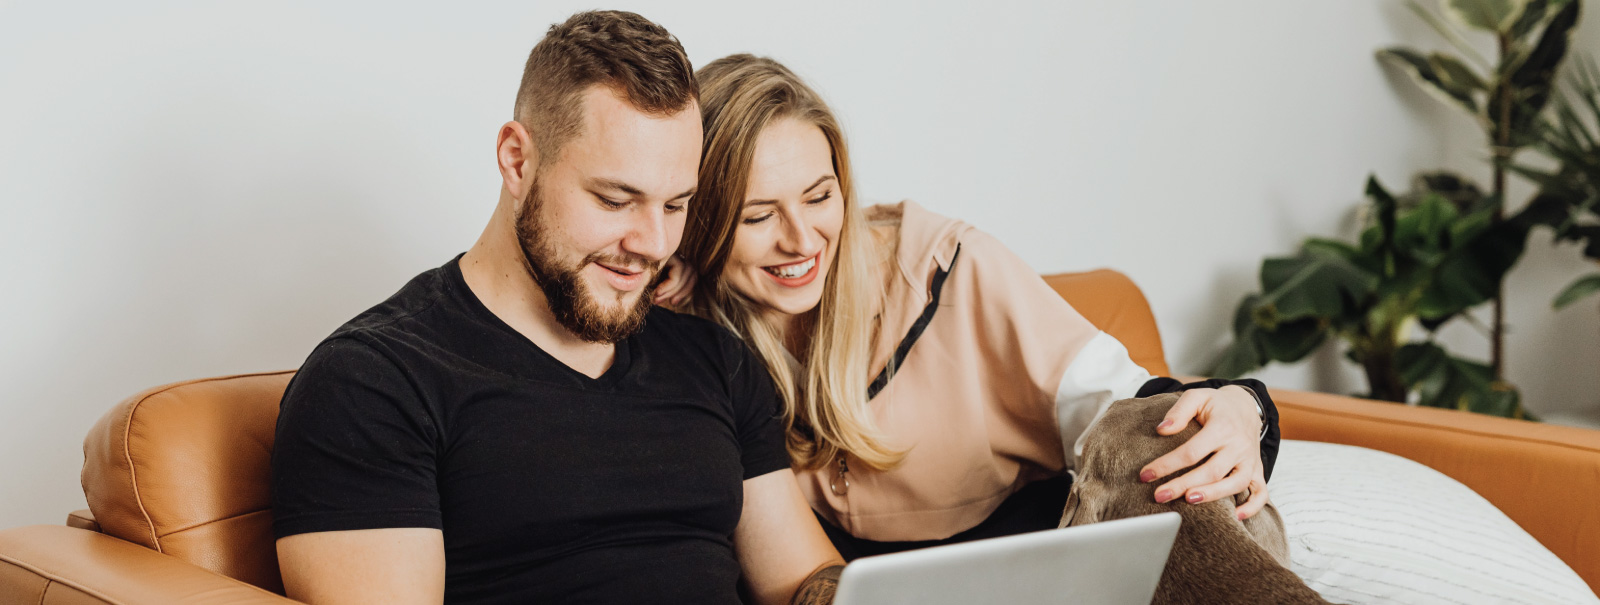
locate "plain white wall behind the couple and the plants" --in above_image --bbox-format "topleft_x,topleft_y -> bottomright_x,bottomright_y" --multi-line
0,0 -> 1600,527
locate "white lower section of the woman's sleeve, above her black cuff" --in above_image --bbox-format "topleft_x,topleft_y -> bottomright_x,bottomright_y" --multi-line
1056,331 -> 1152,469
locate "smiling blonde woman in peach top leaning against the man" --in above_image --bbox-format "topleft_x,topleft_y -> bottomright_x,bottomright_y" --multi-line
658,54 -> 1277,559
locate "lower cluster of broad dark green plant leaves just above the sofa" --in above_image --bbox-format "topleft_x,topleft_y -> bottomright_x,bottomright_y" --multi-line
1211,173 -> 1531,418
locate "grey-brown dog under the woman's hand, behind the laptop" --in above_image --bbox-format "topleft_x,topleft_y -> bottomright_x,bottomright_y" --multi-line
1061,394 -> 1326,603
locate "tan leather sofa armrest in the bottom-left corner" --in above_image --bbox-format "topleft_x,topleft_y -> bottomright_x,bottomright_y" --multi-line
0,525 -> 296,605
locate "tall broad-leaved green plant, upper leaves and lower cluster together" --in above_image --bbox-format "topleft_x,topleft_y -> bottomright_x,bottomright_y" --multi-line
1213,0 -> 1574,418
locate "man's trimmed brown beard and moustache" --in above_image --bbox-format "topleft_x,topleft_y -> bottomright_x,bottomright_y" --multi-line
517,182 -> 661,343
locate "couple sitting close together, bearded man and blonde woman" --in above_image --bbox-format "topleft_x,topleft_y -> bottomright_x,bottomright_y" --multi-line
272,11 -> 1278,603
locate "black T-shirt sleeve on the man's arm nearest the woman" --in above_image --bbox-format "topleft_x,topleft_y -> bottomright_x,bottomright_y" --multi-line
723,335 -> 789,479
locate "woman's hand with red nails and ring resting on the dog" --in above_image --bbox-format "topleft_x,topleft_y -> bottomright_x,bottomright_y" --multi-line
1139,384 -> 1267,519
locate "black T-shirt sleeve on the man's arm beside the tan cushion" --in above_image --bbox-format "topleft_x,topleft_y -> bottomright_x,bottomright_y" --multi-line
272,338 -> 442,538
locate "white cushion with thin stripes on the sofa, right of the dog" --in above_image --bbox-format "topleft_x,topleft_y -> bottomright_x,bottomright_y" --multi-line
1270,440 -> 1600,603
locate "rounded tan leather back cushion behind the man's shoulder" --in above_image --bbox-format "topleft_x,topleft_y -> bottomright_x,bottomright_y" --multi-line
83,371 -> 294,594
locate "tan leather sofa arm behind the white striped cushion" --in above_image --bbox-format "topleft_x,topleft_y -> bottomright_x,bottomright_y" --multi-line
1272,389 -> 1600,587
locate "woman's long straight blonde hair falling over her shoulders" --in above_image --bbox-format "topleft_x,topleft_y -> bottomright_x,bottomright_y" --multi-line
678,54 -> 904,469
